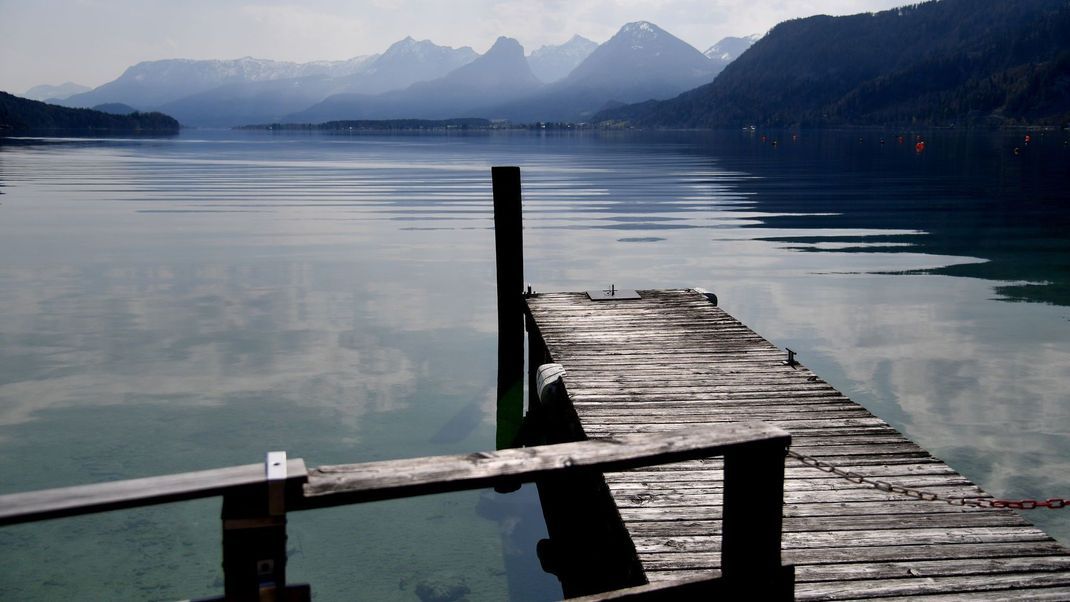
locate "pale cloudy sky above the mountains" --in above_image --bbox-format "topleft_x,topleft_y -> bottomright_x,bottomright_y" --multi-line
0,0 -> 914,93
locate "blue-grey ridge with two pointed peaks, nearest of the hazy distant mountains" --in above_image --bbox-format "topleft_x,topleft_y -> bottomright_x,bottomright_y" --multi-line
297,21 -> 736,122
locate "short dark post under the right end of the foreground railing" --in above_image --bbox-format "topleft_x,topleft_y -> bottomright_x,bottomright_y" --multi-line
721,442 -> 794,600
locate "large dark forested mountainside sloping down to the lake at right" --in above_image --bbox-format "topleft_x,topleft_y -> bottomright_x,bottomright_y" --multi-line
595,0 -> 1070,127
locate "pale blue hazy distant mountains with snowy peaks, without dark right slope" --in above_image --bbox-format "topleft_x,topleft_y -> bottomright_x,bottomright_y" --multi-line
37,21 -> 743,127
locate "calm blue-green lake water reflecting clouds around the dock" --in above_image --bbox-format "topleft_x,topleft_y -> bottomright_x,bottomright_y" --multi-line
0,132 -> 1070,600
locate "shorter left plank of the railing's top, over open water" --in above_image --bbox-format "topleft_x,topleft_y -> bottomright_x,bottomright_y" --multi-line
0,459 -> 306,526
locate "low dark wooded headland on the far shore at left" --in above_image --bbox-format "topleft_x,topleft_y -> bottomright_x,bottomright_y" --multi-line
0,92 -> 179,133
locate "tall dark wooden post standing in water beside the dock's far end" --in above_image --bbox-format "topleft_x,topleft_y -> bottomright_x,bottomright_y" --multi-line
491,167 -> 524,449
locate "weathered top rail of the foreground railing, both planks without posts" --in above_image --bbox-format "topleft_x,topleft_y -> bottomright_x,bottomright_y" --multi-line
0,422 -> 791,526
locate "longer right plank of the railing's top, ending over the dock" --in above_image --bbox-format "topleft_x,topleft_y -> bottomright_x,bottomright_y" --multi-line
293,422 -> 791,510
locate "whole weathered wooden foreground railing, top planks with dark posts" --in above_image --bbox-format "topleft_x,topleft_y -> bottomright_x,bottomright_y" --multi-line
0,422 -> 791,600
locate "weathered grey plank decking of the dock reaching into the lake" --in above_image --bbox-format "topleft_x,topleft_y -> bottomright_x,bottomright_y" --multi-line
526,290 -> 1070,600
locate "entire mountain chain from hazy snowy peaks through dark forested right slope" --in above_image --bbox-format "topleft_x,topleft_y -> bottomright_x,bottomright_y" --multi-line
25,0 -> 1070,128
